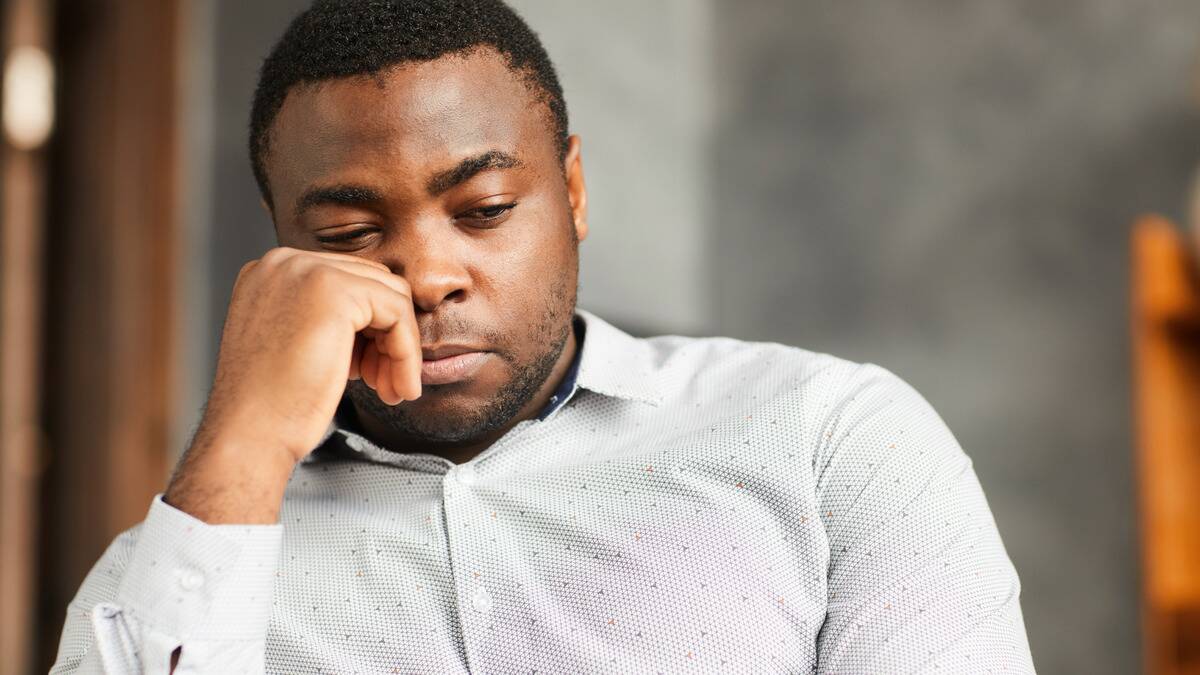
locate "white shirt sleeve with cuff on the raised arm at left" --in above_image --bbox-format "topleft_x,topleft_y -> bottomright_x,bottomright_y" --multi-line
50,495 -> 283,675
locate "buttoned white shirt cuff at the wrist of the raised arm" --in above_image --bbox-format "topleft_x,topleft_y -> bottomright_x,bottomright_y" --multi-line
114,495 -> 283,640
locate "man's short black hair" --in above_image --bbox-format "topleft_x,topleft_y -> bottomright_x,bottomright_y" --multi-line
250,0 -> 568,205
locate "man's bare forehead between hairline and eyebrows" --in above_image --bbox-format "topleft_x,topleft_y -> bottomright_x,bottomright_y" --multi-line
265,49 -> 553,198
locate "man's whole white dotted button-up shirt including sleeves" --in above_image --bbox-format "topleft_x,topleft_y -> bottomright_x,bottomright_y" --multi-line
54,311 -> 1033,674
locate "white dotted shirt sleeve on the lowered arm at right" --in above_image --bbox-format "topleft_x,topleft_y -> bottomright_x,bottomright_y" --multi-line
814,365 -> 1033,673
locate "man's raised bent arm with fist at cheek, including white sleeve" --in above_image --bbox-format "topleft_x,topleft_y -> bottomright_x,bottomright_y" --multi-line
53,249 -> 421,674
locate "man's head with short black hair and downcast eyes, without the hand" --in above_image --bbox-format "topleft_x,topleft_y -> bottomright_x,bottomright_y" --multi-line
250,0 -> 587,443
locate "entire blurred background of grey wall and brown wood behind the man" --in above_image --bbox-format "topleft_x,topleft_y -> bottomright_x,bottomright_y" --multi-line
0,0 -> 1200,674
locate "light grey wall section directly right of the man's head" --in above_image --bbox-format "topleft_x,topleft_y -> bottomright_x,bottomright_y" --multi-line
511,0 -> 715,333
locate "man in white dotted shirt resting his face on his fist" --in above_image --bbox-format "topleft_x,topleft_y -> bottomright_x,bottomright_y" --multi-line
55,0 -> 1032,673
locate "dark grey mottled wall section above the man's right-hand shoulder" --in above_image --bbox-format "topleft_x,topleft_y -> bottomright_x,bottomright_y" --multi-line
710,0 -> 1200,674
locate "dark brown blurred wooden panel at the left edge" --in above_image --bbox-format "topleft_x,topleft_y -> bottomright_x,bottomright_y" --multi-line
41,0 -> 180,664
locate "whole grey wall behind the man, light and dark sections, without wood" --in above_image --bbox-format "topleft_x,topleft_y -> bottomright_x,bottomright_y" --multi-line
197,0 -> 1200,674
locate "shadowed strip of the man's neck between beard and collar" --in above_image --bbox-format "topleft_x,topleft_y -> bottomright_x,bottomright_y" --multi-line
354,328 -> 578,464
